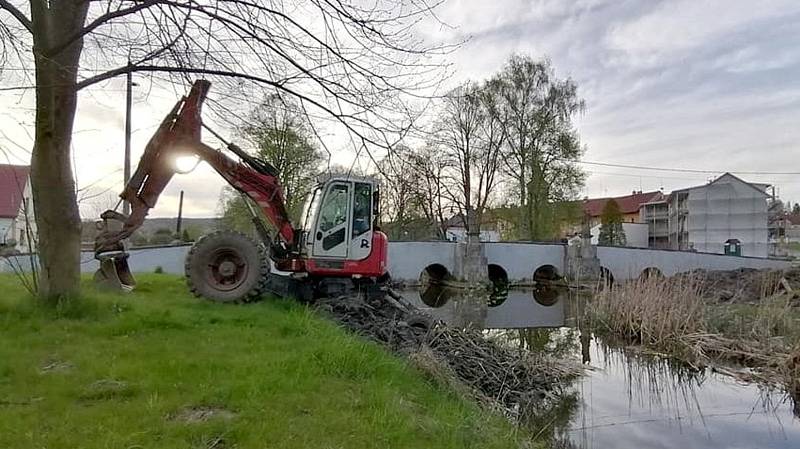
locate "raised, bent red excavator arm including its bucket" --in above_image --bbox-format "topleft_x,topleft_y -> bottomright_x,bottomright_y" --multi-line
95,80 -> 297,285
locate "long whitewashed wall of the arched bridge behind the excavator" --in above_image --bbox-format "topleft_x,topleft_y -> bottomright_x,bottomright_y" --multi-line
0,241 -> 790,283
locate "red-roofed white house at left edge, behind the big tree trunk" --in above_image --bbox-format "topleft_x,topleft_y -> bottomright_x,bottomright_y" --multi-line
0,164 -> 36,253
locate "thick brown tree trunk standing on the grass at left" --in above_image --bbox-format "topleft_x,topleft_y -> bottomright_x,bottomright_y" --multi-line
31,1 -> 89,302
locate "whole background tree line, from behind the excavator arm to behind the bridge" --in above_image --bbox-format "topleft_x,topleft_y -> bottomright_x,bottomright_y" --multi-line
220,56 -> 585,240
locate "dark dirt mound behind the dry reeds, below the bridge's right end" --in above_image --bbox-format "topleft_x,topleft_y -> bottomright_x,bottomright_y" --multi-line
676,268 -> 800,303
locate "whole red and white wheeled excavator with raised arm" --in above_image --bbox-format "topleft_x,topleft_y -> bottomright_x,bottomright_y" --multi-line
95,80 -> 388,302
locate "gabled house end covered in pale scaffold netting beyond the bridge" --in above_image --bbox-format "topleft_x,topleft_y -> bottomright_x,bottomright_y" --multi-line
668,173 -> 770,257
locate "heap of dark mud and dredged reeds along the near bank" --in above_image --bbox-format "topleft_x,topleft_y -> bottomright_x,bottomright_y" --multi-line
318,297 -> 580,414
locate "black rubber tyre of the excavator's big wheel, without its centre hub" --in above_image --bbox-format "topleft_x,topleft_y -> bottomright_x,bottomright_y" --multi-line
185,231 -> 270,302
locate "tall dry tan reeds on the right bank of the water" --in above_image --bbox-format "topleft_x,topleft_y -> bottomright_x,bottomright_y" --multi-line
589,273 -> 800,394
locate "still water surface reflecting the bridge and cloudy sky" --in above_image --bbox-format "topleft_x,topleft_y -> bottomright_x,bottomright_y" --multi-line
404,288 -> 800,449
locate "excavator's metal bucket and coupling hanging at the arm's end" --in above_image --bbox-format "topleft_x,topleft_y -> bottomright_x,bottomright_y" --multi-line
94,210 -> 136,292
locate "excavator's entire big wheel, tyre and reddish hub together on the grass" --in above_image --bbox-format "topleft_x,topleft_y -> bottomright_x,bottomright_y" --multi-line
185,231 -> 269,302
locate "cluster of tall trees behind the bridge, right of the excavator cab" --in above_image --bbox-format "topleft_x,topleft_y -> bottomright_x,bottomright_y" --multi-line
378,55 -> 585,240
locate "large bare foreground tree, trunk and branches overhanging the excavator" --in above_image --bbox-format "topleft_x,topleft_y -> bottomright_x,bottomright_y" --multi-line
0,0 -> 450,300
